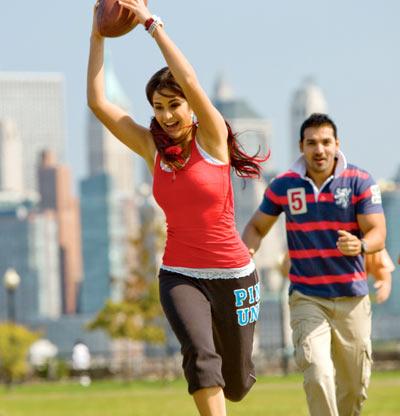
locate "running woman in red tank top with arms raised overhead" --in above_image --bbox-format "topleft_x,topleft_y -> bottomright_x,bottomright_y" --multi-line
87,0 -> 268,415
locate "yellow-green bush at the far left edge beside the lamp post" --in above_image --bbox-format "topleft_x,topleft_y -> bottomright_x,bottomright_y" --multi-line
0,323 -> 40,387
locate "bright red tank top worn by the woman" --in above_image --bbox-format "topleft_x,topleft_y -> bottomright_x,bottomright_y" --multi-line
153,140 -> 250,268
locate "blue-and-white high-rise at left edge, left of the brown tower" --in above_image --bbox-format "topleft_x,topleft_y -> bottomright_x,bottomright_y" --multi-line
0,193 -> 61,322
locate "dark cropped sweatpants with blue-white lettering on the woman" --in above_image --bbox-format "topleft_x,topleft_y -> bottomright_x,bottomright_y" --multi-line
159,269 -> 260,401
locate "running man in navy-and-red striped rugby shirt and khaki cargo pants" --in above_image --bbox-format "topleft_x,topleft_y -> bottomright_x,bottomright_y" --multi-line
243,114 -> 386,416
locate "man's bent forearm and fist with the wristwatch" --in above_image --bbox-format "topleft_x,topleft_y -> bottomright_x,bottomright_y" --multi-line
337,213 -> 386,256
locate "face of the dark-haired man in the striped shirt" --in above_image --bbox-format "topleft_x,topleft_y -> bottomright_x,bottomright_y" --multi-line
300,125 -> 339,176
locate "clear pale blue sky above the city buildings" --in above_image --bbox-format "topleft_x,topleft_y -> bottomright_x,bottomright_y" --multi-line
0,0 -> 400,184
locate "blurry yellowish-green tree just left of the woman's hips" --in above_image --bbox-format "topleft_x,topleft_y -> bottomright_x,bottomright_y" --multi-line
88,192 -> 165,343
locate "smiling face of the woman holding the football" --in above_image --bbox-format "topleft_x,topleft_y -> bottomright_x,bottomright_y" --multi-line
153,90 -> 192,142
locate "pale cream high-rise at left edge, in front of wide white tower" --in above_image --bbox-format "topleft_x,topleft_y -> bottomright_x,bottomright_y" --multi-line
0,120 -> 24,193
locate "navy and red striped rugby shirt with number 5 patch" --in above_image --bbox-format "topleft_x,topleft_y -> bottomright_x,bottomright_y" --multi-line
259,151 -> 383,297
